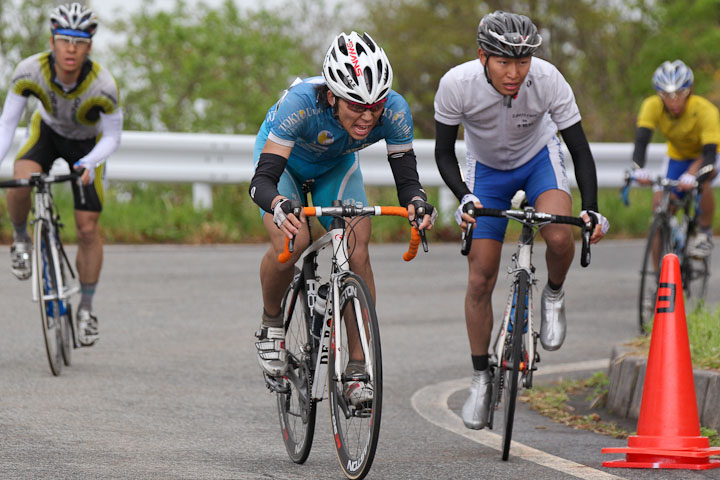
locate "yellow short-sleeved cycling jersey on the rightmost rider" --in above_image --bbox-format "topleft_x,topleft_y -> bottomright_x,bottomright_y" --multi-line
637,95 -> 720,160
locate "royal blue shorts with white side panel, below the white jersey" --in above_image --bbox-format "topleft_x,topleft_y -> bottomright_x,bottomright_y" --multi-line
472,137 -> 570,242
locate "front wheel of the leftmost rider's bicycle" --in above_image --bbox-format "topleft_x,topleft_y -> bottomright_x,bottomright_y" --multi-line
33,220 -> 63,376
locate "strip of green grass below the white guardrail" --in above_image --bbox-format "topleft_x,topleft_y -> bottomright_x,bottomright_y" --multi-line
0,182 -> 720,243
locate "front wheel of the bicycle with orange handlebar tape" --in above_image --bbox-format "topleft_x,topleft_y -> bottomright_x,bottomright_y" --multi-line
328,273 -> 382,480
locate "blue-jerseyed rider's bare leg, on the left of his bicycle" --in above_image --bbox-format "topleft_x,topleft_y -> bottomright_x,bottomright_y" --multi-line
260,213 -> 310,317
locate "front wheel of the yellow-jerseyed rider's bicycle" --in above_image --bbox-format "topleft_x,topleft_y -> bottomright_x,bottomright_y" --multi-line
638,214 -> 672,334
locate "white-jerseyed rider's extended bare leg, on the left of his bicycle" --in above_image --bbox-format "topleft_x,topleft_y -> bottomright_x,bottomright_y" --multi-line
465,238 -> 502,356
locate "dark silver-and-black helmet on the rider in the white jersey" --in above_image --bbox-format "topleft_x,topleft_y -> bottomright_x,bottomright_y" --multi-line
478,10 -> 542,58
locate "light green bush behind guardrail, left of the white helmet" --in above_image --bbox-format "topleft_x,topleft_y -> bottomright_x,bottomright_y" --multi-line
111,0 -> 319,133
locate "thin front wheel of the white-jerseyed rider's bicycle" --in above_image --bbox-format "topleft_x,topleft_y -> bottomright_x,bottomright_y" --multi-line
502,270 -> 530,460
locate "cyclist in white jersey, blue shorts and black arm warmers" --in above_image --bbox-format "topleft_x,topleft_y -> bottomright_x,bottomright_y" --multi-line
435,11 -> 609,429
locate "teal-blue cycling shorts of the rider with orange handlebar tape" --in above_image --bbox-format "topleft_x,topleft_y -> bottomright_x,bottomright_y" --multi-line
253,123 -> 367,230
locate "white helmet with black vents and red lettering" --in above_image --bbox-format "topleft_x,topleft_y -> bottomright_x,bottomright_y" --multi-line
323,32 -> 392,105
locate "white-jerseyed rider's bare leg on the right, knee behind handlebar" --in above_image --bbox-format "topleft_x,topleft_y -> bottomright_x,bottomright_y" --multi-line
535,190 -> 575,285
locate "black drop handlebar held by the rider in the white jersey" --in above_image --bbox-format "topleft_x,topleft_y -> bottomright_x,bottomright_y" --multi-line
460,204 -> 597,267
